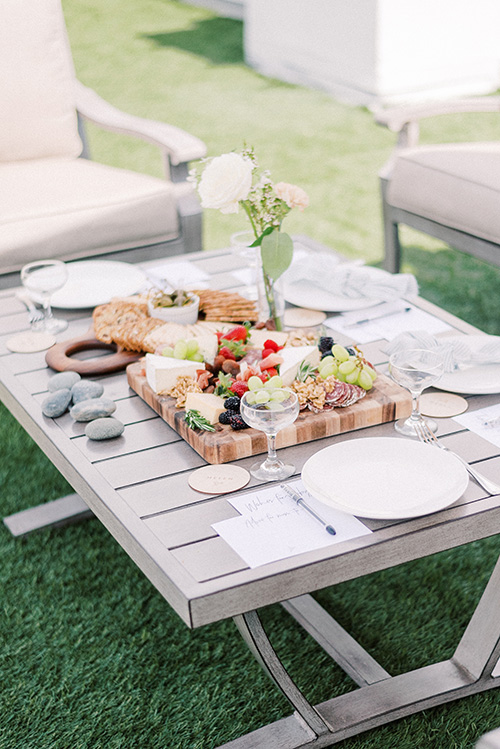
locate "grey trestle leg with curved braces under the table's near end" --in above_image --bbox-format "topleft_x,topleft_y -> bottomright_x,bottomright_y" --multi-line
224,558 -> 500,749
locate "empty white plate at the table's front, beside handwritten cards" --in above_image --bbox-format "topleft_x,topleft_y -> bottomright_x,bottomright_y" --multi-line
302,437 -> 469,520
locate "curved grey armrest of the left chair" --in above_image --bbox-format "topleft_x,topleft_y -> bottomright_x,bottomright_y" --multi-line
76,81 -> 207,166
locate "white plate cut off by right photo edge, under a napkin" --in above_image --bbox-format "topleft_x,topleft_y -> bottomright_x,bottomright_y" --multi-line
434,335 -> 500,395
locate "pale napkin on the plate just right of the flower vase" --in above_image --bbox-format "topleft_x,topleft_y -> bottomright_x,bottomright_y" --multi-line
283,252 -> 418,302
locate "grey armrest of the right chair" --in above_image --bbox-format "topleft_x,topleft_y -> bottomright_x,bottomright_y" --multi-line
375,96 -> 500,147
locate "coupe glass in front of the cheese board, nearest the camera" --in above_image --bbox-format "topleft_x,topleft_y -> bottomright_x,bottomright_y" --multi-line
240,388 -> 299,481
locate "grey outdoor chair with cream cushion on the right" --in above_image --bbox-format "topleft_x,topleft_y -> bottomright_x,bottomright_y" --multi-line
376,96 -> 500,273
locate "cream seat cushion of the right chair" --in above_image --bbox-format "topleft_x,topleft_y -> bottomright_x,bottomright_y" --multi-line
387,142 -> 500,242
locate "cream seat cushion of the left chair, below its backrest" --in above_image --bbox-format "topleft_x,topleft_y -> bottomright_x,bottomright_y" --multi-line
0,158 -> 186,271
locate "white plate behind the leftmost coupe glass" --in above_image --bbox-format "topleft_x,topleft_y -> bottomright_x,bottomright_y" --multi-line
51,260 -> 146,309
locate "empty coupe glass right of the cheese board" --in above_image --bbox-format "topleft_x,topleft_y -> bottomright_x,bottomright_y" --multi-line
389,349 -> 444,437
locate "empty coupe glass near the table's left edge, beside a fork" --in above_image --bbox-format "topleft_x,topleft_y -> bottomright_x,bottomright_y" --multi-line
21,260 -> 68,333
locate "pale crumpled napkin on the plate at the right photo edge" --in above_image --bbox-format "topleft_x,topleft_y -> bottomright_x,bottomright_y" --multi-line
385,330 -> 500,372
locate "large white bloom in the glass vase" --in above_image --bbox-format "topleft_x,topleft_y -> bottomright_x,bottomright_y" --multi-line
198,153 -> 253,213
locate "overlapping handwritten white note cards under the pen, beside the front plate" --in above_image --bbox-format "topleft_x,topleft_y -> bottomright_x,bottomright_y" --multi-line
212,480 -> 371,568
